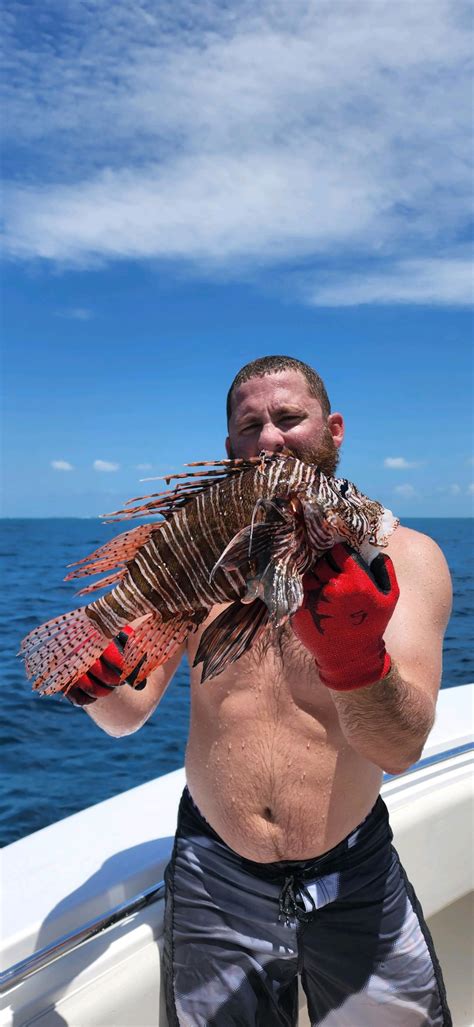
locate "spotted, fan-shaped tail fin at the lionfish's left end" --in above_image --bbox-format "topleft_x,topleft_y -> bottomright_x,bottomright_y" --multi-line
19,608 -> 110,695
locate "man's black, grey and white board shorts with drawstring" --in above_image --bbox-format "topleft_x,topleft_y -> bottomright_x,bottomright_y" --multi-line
163,789 -> 452,1027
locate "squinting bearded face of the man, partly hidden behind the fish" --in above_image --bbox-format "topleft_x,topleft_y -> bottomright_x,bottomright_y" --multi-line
226,370 -> 344,474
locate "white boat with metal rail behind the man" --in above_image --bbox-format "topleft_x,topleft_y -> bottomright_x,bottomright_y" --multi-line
0,684 -> 474,1027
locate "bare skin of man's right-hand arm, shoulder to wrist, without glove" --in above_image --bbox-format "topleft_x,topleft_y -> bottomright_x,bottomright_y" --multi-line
330,528 -> 451,773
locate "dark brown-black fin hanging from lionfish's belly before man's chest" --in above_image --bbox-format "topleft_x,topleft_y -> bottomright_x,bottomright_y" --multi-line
193,599 -> 269,682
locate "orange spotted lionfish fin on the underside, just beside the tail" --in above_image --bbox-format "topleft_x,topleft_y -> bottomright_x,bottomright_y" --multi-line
120,610 -> 208,688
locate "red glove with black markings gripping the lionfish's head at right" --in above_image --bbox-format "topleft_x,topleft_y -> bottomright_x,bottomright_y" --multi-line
291,544 -> 399,691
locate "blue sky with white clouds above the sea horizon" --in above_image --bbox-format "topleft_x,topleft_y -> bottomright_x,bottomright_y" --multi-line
1,0 -> 474,518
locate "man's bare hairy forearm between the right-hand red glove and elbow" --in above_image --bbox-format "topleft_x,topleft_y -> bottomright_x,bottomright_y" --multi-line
330,664 -> 435,773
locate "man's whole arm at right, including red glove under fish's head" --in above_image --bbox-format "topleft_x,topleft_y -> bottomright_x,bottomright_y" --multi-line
292,528 -> 451,773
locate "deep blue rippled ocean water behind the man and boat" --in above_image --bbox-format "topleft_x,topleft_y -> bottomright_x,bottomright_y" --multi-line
0,519 -> 474,845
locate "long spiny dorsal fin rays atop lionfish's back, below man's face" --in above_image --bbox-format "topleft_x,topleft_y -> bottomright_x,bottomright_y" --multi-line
104,457 -> 262,524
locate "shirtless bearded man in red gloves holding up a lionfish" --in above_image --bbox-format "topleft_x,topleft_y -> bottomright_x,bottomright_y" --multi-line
67,356 -> 451,1027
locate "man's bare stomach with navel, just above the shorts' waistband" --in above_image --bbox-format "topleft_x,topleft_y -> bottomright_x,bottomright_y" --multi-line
186,710 -> 382,863
